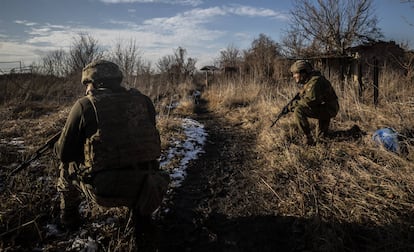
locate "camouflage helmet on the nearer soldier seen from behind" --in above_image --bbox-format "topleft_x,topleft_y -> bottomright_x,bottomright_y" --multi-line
81,60 -> 123,85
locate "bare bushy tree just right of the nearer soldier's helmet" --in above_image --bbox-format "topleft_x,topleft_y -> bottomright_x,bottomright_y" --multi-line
112,40 -> 142,87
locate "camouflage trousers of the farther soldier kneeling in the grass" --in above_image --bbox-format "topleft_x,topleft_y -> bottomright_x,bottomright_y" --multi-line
294,102 -> 339,138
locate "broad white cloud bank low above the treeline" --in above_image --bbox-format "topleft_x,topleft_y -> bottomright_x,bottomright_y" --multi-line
8,3 -> 284,68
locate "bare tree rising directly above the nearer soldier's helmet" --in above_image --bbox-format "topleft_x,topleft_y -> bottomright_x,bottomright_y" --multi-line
68,33 -> 103,73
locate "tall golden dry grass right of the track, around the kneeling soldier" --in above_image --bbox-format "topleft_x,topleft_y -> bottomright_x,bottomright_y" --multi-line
204,68 -> 414,251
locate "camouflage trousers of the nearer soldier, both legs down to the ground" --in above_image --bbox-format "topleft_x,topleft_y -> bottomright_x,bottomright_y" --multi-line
57,161 -> 159,246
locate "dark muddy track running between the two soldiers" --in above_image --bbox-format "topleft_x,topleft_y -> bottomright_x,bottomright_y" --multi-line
159,97 -> 298,251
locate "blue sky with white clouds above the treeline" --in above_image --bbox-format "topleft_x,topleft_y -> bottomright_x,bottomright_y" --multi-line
0,0 -> 414,70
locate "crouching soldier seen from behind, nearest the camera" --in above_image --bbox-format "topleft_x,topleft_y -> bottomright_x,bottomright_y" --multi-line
55,60 -> 169,250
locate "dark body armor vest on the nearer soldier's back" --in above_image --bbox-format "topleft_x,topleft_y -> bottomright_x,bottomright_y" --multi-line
84,90 -> 161,173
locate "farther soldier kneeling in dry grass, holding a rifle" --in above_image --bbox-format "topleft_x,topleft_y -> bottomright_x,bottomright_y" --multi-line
289,60 -> 339,145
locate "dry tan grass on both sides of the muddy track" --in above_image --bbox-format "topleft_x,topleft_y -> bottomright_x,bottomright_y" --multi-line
0,68 -> 414,251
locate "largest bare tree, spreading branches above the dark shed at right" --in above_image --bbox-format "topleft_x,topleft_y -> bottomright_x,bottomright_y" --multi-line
291,0 -> 382,54
